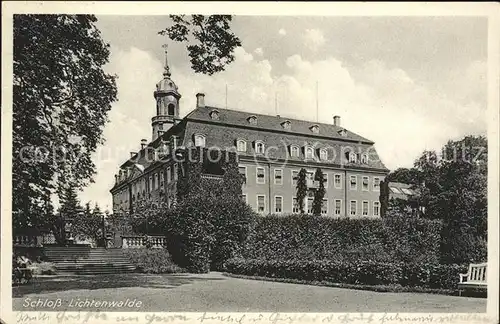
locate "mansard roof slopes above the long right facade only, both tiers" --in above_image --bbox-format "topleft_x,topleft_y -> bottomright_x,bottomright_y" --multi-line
183,107 -> 388,172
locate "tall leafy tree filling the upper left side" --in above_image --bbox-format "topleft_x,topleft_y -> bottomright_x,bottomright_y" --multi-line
13,15 -> 116,232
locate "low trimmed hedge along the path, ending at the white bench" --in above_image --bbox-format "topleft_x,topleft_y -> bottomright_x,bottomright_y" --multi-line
225,258 -> 467,289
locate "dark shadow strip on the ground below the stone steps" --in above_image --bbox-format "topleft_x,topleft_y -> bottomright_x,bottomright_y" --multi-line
12,273 -> 226,298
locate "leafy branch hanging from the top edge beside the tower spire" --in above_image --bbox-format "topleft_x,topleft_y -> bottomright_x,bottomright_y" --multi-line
159,15 -> 241,75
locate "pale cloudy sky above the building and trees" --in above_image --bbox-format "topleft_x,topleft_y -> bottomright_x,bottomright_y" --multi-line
80,16 -> 488,210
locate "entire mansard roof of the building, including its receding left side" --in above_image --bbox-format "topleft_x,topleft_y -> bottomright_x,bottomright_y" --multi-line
112,106 -> 389,190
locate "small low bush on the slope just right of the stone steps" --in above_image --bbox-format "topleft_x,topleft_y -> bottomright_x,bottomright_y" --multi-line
123,249 -> 185,273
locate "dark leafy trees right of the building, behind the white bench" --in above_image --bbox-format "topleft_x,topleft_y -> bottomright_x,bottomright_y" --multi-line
380,136 -> 488,263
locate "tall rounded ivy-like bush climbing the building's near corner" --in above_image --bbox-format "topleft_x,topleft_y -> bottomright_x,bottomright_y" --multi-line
163,148 -> 256,273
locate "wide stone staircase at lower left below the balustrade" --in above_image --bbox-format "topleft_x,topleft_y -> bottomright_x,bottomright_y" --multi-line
44,246 -> 135,275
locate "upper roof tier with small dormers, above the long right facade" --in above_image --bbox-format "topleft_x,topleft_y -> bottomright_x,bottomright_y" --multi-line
186,106 -> 374,144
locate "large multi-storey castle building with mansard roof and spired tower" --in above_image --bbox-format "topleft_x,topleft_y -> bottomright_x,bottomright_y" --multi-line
111,49 -> 389,217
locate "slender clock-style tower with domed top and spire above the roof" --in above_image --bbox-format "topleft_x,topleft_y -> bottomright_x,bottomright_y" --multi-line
151,45 -> 181,141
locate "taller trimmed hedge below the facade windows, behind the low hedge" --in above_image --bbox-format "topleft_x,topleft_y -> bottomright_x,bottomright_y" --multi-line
239,215 -> 441,263
